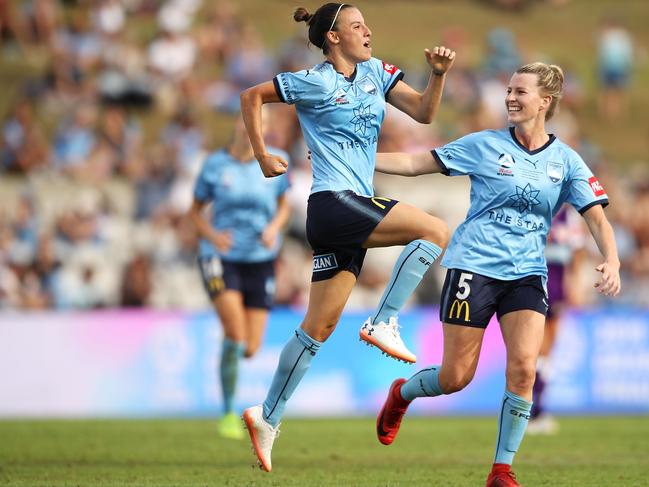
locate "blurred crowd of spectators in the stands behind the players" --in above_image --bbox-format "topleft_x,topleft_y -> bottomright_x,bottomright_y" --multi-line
0,0 -> 649,309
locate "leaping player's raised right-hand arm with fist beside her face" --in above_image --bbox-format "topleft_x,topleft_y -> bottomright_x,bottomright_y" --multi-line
388,46 -> 455,123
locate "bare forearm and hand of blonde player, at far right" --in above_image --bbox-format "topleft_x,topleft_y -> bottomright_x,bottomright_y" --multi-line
584,205 -> 621,296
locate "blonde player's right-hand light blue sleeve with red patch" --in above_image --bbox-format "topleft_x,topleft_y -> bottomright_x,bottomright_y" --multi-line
562,152 -> 608,215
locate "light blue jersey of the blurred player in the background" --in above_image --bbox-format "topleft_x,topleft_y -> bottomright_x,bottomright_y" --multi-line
194,147 -> 289,263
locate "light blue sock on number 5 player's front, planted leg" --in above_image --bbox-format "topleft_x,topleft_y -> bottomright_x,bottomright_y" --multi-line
494,391 -> 532,465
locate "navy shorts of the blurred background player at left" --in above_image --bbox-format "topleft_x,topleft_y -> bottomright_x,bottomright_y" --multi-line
198,255 -> 275,309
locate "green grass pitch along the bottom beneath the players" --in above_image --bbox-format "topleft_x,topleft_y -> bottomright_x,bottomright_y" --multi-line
0,417 -> 649,487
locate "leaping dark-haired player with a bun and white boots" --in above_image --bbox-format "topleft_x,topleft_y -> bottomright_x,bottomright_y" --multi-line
241,3 -> 455,471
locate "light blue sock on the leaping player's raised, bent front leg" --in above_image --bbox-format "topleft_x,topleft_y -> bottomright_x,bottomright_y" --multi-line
372,240 -> 442,323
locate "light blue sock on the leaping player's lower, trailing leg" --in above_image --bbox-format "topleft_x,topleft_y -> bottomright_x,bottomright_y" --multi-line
264,328 -> 322,427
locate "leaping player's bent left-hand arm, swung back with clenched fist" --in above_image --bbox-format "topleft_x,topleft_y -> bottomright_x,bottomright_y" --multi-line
239,81 -> 288,178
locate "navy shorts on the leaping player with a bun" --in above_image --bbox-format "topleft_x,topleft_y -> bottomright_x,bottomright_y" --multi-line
306,191 -> 398,282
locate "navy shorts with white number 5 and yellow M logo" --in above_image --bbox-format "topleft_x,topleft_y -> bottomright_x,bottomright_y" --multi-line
439,269 -> 548,328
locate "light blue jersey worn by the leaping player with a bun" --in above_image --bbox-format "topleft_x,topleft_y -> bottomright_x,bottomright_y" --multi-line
274,58 -> 403,196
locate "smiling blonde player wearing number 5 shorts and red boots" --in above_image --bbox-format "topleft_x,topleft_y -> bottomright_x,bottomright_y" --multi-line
377,63 -> 620,486
